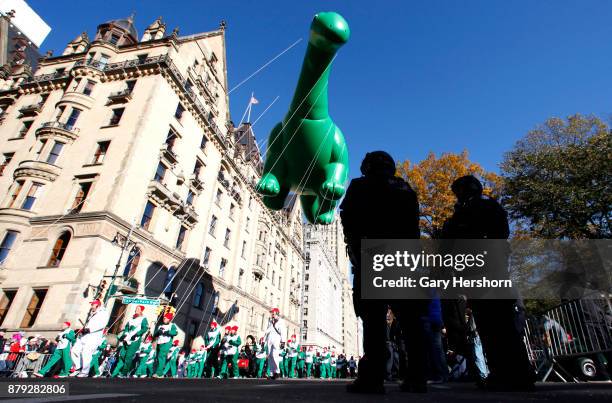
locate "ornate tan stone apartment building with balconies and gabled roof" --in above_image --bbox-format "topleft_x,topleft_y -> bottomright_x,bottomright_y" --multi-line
0,14 -> 304,343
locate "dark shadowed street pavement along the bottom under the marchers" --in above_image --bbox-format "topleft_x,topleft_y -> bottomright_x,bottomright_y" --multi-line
0,378 -> 612,403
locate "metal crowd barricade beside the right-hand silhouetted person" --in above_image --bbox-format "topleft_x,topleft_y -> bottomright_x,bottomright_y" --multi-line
525,299 -> 612,382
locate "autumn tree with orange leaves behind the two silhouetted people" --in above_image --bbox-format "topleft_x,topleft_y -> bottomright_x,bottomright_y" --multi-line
397,151 -> 503,237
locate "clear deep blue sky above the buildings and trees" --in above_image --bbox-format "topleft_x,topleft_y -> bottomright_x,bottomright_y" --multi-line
29,0 -> 612,176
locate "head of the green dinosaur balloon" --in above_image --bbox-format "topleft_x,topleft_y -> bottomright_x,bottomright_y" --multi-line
309,11 -> 351,52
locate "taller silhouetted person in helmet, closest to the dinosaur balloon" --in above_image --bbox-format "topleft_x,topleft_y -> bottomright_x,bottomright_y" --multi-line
340,151 -> 427,393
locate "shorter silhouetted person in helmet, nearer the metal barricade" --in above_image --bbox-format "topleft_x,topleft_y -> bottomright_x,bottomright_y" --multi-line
442,175 -> 534,390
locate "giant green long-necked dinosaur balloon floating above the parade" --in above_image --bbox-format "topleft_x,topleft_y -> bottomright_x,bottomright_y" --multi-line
257,12 -> 350,224
